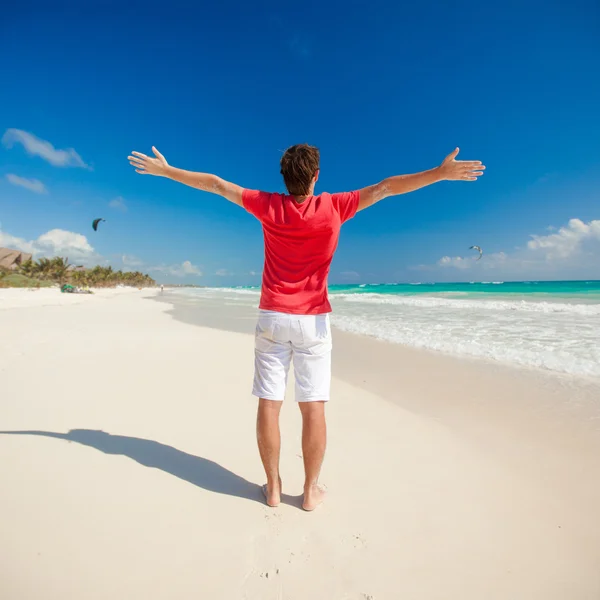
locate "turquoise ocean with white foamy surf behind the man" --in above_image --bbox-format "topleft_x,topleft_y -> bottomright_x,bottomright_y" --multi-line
170,281 -> 600,378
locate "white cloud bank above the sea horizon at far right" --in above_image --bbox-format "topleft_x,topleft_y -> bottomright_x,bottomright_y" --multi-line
424,219 -> 600,279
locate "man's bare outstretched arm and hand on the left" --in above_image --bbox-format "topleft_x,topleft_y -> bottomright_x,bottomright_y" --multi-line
127,146 -> 244,206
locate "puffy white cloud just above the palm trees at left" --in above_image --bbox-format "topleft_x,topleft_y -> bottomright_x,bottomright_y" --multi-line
0,229 -> 103,266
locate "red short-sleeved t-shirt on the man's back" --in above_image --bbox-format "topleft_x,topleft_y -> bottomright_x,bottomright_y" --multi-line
242,190 -> 359,315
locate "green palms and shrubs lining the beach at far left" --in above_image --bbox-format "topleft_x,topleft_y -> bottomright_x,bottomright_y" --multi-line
0,256 -> 156,287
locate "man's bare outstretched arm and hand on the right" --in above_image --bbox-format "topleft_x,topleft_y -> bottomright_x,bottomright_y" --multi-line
358,148 -> 485,210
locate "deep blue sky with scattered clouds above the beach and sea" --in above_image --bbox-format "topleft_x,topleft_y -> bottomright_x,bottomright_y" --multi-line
0,0 -> 600,285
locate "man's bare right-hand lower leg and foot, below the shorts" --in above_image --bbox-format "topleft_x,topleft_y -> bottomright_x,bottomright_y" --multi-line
298,402 -> 327,510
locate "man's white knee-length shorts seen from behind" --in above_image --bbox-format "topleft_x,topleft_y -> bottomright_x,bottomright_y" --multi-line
252,310 -> 331,402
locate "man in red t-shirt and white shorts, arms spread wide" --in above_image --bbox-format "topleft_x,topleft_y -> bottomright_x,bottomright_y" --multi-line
129,144 -> 485,511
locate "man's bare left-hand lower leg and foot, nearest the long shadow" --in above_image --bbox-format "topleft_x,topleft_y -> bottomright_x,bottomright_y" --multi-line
256,398 -> 283,506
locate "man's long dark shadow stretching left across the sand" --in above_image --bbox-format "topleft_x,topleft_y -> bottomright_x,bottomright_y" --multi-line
0,429 -> 301,508
